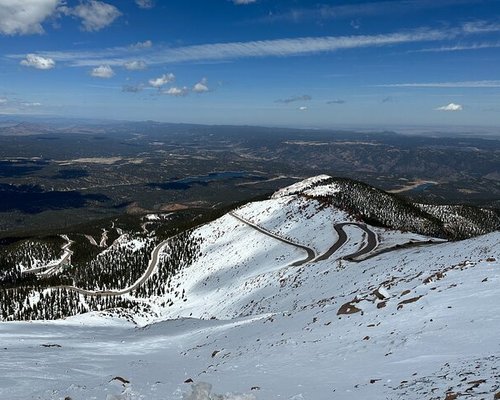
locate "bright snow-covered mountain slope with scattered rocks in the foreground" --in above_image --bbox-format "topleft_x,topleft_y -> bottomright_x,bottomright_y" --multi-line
0,178 -> 500,400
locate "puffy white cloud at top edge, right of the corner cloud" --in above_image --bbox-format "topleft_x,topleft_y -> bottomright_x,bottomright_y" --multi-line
60,0 -> 122,32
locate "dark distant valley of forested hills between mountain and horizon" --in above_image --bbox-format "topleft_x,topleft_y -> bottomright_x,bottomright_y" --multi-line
0,120 -> 500,236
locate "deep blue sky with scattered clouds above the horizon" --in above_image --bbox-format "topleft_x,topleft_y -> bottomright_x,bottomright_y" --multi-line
0,0 -> 500,128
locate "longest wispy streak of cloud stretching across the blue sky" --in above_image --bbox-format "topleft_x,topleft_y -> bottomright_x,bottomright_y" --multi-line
8,23 -> 500,67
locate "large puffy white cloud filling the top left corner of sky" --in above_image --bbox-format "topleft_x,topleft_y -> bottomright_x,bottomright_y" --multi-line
0,0 -> 60,35
